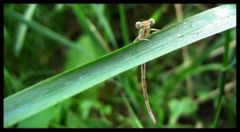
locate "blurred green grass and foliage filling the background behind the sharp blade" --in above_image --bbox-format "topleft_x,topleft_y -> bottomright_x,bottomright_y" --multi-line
3,4 -> 237,128
